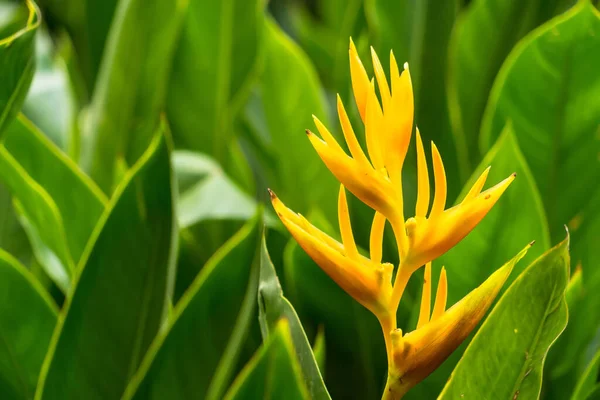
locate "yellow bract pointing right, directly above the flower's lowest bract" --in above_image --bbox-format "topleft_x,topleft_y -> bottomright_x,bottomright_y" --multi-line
405,174 -> 516,268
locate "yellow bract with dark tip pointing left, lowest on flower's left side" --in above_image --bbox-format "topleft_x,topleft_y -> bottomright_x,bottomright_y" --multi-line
270,192 -> 391,315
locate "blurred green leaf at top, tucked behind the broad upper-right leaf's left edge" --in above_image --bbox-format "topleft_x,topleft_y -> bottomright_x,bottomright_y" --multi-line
448,0 -> 565,168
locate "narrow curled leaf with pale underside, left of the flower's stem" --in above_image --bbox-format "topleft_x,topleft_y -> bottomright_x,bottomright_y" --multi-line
258,236 -> 331,399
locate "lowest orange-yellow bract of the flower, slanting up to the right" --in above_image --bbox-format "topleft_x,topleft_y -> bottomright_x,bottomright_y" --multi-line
388,245 -> 531,398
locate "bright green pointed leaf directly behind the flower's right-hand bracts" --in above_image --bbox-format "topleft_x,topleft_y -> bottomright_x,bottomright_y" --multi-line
407,126 -> 550,398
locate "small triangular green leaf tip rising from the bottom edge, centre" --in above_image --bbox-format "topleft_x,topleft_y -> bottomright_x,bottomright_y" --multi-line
225,320 -> 311,400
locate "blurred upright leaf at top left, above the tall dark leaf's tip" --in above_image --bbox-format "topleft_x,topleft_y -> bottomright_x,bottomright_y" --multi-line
81,0 -> 187,193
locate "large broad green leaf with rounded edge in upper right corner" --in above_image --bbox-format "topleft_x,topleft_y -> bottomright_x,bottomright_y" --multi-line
481,1 -> 600,236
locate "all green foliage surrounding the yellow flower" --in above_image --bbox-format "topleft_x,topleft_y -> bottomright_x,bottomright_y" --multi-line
0,0 -> 600,400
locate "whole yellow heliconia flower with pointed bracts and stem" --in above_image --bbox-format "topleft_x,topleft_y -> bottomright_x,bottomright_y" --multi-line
271,40 -> 516,399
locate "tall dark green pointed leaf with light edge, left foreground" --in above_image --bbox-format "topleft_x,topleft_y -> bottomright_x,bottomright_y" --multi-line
36,128 -> 177,400
